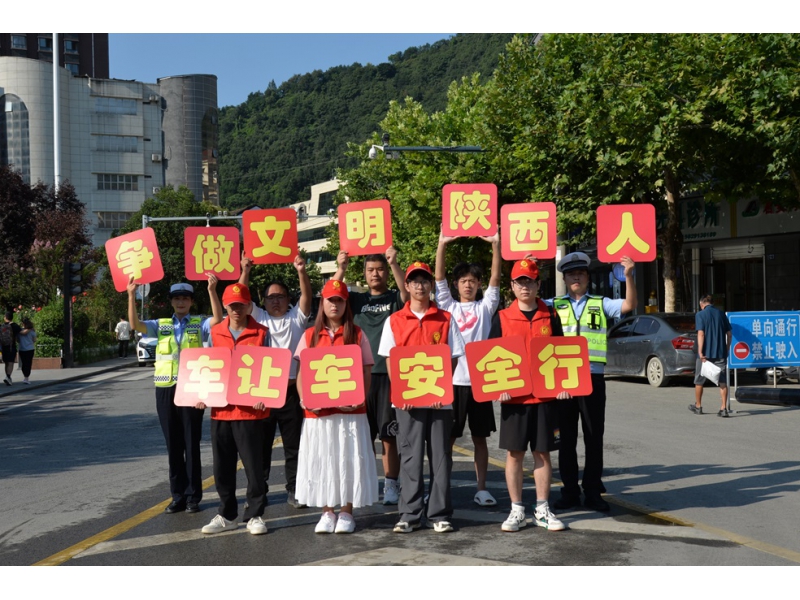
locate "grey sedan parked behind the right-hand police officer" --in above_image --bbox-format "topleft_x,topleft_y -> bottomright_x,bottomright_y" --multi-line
605,313 -> 697,387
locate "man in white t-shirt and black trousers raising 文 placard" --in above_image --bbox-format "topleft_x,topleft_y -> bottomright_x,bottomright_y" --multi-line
239,255 -> 312,508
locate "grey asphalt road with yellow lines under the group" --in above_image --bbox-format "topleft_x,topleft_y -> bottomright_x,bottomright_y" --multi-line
0,369 -> 800,566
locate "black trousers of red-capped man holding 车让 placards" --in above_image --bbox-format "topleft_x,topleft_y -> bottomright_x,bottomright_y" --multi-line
211,419 -> 267,522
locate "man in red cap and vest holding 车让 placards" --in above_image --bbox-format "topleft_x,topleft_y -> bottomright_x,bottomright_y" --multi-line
197,283 -> 269,535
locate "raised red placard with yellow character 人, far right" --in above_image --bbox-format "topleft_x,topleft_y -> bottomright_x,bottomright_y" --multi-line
597,204 -> 656,262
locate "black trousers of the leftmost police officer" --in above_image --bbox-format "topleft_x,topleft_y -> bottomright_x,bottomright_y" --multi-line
156,385 -> 204,502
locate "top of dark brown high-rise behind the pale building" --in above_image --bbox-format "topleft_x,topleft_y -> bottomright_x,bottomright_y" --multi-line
0,33 -> 109,79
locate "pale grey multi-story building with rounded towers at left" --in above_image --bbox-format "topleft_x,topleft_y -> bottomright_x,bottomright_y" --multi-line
0,56 -> 219,245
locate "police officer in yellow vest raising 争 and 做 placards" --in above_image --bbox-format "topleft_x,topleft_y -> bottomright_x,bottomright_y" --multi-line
128,273 -> 222,514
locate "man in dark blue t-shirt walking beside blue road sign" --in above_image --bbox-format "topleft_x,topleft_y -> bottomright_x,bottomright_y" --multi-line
689,294 -> 733,417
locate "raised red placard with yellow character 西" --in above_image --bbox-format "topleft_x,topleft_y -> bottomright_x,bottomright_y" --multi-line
500,202 -> 557,260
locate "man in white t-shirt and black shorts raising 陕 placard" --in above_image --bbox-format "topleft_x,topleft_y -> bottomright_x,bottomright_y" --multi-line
435,234 -> 502,506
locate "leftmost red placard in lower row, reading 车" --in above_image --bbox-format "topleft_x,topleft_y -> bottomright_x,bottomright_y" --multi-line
175,348 -> 231,407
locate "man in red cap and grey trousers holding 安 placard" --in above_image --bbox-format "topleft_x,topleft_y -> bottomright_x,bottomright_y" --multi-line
378,262 -> 464,533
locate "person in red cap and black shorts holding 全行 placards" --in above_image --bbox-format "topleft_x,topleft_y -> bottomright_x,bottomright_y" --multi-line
489,260 -> 570,531
